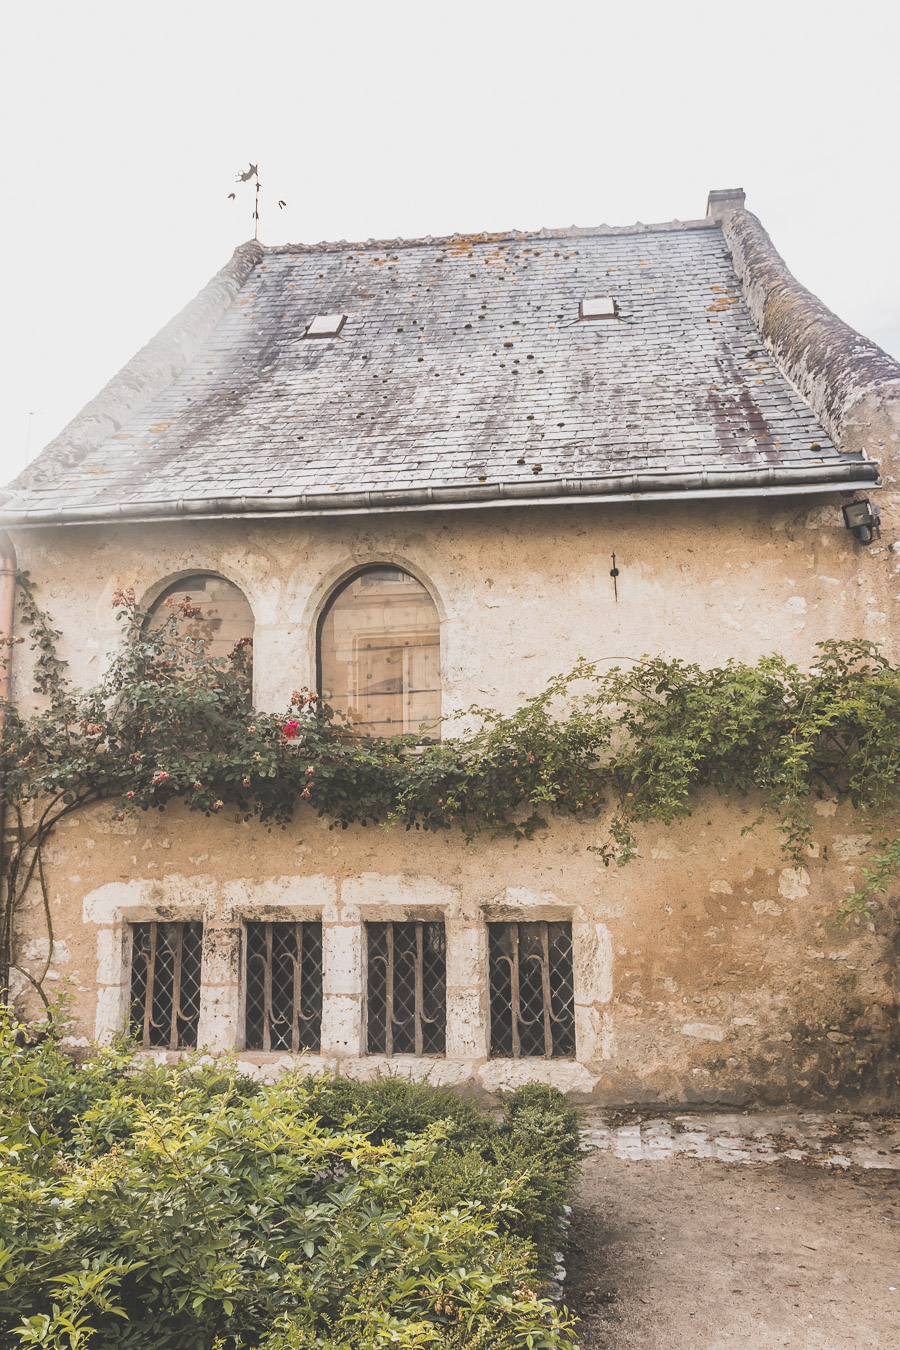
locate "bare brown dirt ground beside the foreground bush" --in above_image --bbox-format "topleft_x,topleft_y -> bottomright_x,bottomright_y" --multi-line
565,1153 -> 900,1350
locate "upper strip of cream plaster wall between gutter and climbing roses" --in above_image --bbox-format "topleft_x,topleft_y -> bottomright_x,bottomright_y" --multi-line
10,498 -> 900,709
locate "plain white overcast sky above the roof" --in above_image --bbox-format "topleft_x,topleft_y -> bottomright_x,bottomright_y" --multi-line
0,0 -> 900,482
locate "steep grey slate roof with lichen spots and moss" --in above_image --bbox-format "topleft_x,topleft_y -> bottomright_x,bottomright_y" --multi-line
1,221 -> 877,522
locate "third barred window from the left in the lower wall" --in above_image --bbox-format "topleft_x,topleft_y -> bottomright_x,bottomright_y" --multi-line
366,922 -> 447,1054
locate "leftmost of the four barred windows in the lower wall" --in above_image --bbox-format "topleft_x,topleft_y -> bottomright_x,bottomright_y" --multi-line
131,922 -> 204,1050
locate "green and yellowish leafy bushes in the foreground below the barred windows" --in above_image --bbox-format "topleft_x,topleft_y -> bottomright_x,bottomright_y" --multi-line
0,1018 -> 578,1350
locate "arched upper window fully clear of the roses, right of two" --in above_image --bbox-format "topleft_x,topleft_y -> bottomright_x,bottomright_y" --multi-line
318,567 -> 441,736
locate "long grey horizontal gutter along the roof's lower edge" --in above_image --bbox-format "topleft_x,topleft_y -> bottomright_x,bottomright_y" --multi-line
0,459 -> 881,528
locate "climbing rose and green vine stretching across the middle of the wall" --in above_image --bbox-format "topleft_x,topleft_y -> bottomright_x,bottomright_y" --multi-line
0,574 -> 900,996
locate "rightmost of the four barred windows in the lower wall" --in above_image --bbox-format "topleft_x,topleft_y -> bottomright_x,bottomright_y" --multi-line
487,923 -> 575,1060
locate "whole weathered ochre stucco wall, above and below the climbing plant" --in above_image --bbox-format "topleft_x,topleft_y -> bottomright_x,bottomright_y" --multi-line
7,497 -> 900,1104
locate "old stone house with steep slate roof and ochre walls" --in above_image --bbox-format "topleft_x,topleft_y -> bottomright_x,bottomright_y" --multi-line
0,192 -> 900,1104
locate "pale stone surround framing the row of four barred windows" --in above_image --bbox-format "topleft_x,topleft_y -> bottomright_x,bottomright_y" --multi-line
84,872 -> 613,1091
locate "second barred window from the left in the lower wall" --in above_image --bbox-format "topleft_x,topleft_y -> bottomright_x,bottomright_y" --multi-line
244,923 -> 322,1052
